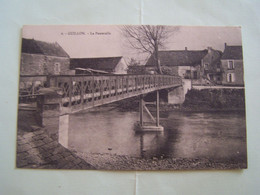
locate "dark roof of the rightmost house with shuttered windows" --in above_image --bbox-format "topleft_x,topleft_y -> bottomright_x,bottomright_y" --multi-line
221,45 -> 243,60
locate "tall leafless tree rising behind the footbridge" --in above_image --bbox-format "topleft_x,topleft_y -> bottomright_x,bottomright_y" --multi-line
122,25 -> 177,74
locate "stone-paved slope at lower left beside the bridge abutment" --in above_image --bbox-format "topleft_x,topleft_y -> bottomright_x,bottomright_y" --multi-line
16,110 -> 95,169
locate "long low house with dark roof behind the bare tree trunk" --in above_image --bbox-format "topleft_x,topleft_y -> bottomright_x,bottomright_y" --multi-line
145,47 -> 208,79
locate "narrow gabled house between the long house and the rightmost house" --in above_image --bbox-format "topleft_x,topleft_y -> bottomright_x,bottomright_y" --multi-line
200,47 -> 223,84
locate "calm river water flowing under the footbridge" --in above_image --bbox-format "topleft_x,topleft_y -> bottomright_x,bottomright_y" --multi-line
68,106 -> 247,160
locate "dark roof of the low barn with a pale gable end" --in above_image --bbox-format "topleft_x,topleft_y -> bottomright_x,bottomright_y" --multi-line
70,56 -> 122,72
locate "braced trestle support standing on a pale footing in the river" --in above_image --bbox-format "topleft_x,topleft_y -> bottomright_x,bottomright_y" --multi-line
137,91 -> 164,132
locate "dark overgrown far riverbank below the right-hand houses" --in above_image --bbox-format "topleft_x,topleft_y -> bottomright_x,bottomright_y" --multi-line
114,89 -> 245,112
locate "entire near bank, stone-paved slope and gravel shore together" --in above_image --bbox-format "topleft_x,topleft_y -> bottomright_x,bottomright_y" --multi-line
16,106 -> 247,171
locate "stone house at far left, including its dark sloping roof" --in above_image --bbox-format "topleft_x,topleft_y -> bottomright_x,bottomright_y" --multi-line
20,38 -> 71,75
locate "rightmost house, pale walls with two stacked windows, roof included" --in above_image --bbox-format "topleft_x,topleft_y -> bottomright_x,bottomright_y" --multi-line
221,43 -> 244,86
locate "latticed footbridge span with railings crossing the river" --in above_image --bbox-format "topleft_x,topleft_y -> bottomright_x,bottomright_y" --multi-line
19,75 -> 182,109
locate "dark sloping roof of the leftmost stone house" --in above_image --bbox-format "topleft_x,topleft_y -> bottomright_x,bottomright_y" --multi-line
22,38 -> 69,58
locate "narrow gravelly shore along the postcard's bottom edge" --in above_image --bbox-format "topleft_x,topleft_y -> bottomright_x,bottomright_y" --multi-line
76,152 -> 247,171
